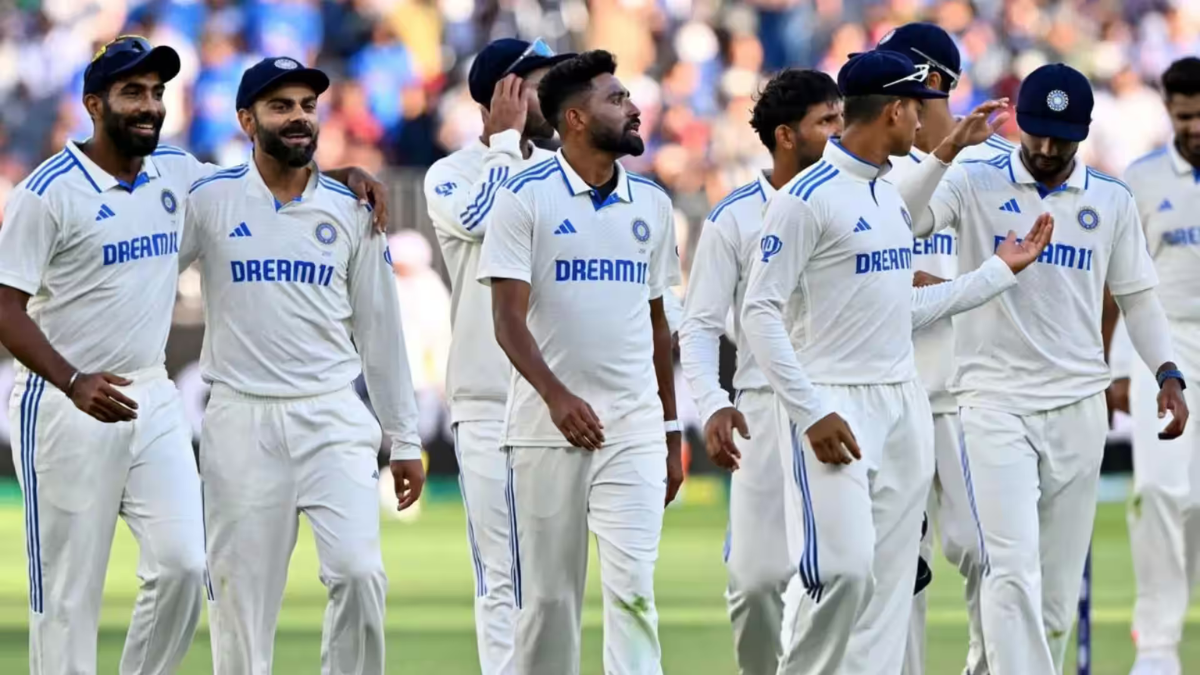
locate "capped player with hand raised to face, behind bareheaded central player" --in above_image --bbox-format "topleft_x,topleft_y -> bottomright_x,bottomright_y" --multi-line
425,38 -> 574,675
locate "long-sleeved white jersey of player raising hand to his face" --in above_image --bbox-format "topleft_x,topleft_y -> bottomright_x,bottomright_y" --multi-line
425,130 -> 554,422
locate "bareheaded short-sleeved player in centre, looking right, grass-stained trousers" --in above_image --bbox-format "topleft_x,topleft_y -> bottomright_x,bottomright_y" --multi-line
479,50 -> 683,675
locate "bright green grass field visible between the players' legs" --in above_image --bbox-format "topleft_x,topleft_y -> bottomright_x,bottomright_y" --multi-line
0,480 -> 1200,675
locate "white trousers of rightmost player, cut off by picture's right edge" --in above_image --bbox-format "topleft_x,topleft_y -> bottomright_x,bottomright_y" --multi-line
1128,321 -> 1200,652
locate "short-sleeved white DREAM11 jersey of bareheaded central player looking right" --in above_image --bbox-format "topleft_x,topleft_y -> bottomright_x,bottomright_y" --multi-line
479,151 -> 679,446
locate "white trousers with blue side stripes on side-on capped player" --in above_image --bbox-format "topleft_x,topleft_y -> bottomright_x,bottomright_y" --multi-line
779,381 -> 934,675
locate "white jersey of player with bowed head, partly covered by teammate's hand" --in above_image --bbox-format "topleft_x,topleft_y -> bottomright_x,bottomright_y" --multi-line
916,144 -> 1158,414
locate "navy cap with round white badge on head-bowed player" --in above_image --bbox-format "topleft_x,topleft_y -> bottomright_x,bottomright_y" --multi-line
1016,64 -> 1094,142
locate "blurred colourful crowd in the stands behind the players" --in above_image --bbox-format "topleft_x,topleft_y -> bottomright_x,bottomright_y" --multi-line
0,0 -> 1200,437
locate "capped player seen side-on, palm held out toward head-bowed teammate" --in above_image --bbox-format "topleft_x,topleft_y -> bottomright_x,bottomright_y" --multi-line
742,52 -> 1036,674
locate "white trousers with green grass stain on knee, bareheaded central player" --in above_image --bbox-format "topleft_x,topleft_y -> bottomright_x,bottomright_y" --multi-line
508,438 -> 667,675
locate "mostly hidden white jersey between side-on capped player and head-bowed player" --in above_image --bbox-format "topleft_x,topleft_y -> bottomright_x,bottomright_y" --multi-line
887,135 -> 1016,414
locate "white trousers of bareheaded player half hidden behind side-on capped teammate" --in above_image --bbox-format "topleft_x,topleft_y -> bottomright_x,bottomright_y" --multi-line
725,389 -> 796,675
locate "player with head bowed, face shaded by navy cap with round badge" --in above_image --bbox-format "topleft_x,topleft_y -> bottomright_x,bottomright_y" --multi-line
904,64 -> 1188,675
